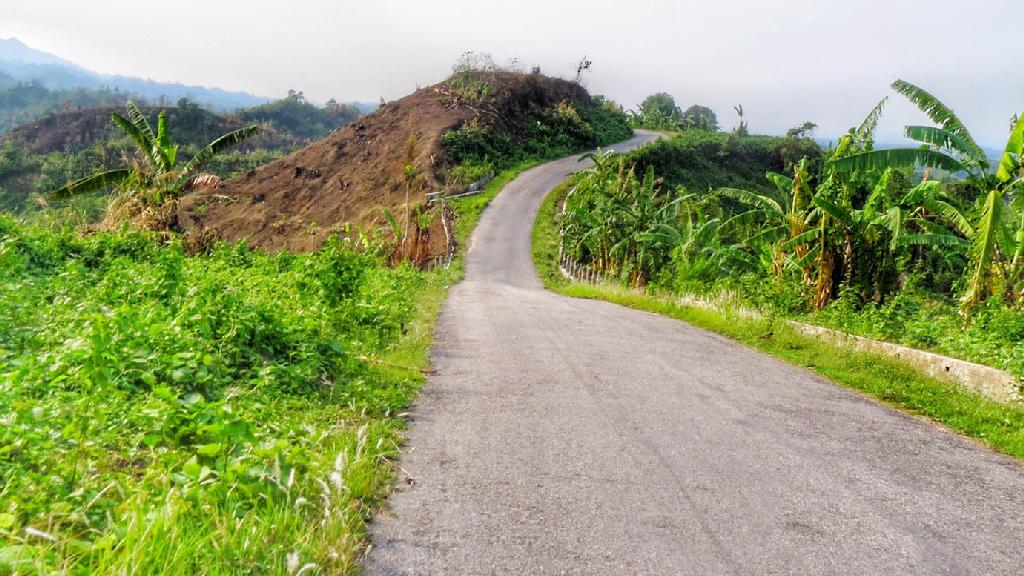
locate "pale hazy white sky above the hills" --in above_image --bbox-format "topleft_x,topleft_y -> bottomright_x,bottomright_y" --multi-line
0,0 -> 1024,147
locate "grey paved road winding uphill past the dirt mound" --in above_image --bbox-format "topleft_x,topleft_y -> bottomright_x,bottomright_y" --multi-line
367,131 -> 1024,575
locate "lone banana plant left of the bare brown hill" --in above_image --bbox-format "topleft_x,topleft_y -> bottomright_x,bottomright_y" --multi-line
50,101 -> 260,203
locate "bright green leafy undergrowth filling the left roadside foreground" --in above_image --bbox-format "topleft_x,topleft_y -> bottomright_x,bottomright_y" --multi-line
0,217 -> 424,574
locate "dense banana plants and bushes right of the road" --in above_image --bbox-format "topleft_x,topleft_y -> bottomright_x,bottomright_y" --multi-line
560,81 -> 1024,376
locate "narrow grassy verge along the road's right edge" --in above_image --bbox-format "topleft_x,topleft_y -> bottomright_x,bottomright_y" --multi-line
532,178 -> 1024,459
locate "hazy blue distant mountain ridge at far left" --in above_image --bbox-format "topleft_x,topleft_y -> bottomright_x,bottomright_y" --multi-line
0,38 -> 270,112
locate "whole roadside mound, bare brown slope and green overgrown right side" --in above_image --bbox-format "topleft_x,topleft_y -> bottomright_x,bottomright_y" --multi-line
178,59 -> 631,252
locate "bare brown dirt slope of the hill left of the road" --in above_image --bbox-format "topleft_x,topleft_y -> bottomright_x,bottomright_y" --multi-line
178,73 -> 592,251
